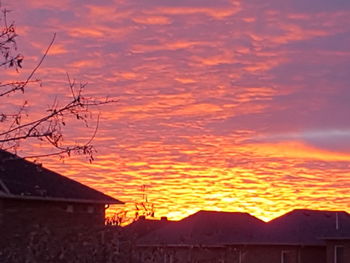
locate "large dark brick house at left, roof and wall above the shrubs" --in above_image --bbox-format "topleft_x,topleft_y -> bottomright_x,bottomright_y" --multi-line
0,150 -> 122,232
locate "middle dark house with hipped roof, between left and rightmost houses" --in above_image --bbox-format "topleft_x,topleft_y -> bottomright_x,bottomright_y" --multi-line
138,211 -> 265,263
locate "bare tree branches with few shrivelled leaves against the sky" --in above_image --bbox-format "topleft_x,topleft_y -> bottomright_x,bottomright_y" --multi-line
0,6 -> 115,162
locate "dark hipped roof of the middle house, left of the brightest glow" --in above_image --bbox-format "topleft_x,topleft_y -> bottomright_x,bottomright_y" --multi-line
139,211 -> 265,246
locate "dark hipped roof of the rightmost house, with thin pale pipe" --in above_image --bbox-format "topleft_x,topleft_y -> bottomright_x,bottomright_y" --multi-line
263,209 -> 350,245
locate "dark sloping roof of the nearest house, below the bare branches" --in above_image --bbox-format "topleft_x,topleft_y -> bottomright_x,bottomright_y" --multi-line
0,150 -> 122,204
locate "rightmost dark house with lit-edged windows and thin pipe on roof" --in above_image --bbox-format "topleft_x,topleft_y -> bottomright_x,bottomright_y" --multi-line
263,209 -> 350,263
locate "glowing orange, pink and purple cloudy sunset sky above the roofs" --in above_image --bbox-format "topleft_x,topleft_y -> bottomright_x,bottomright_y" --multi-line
0,0 -> 350,223
